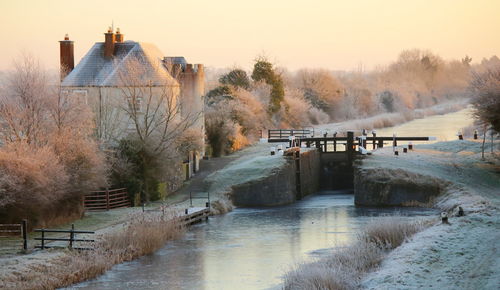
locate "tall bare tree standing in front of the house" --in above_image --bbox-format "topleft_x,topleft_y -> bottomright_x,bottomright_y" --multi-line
115,58 -> 203,200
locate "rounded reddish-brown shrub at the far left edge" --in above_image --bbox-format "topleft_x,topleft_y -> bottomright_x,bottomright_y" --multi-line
0,143 -> 69,226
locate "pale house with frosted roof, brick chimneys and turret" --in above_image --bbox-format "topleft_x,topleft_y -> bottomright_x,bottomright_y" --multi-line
60,29 -> 205,178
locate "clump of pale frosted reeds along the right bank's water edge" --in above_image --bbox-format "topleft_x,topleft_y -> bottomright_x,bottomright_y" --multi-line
284,216 -> 424,290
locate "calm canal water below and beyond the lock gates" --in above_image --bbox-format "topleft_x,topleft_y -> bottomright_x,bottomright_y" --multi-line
72,110 -> 472,290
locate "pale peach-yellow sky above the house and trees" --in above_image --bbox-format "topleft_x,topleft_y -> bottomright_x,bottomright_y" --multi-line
0,0 -> 500,70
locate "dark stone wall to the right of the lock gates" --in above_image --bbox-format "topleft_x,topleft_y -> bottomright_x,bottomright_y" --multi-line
354,168 -> 446,206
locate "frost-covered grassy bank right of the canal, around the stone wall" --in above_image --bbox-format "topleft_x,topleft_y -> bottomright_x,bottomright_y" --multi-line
361,140 -> 500,289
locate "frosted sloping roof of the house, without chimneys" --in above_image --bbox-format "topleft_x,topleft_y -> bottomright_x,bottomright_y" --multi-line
61,41 -> 178,87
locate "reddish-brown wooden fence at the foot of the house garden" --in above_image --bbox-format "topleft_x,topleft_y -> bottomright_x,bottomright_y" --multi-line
83,188 -> 131,211
